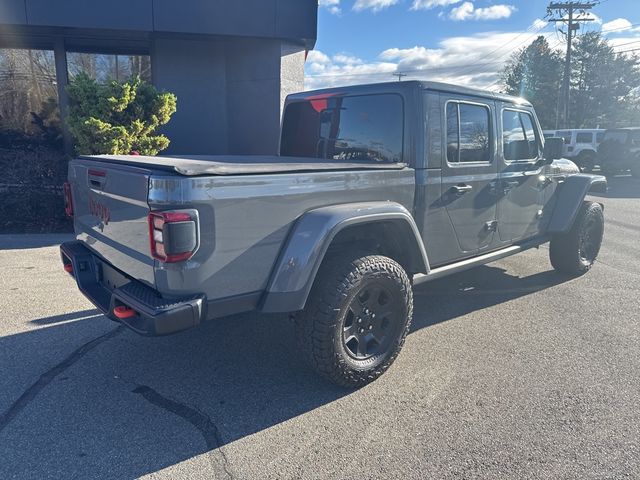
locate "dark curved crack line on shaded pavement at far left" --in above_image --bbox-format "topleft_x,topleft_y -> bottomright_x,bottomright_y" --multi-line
0,325 -> 125,432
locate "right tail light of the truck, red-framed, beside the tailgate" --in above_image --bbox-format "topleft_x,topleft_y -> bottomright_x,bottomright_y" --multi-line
148,212 -> 198,263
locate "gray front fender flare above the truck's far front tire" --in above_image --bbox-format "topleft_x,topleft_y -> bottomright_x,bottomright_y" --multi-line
547,173 -> 607,235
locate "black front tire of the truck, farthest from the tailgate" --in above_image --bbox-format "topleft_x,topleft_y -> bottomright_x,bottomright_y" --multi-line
549,201 -> 604,277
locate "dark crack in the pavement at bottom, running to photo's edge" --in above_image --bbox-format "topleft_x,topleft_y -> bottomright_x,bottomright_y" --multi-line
133,385 -> 234,480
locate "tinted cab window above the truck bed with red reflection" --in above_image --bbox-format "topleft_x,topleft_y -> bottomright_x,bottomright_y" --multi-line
280,94 -> 404,163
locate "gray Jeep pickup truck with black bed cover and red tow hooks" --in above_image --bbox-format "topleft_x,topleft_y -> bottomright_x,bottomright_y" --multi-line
61,82 -> 606,387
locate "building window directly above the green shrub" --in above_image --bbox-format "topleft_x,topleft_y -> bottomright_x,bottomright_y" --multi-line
67,52 -> 151,83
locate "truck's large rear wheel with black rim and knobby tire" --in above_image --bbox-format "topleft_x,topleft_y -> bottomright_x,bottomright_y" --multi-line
296,255 -> 413,388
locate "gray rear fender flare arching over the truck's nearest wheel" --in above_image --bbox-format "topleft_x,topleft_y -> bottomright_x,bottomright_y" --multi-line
259,201 -> 429,312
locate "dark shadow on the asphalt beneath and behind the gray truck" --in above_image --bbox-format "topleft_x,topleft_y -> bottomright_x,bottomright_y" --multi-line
0,266 -> 565,478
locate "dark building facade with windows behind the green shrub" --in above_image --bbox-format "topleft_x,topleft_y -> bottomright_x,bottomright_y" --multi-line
0,0 -> 318,154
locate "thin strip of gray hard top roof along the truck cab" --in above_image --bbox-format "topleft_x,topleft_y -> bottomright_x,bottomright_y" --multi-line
288,80 -> 531,107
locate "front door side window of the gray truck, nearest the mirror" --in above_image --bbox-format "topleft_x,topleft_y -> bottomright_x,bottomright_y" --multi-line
502,110 -> 540,161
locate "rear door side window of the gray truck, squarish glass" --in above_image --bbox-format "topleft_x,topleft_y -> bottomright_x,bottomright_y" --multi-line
446,102 -> 491,163
